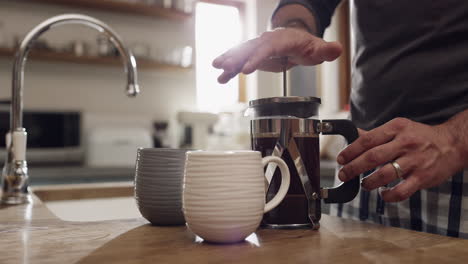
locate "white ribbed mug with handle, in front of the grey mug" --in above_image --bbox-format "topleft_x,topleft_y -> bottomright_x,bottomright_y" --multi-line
182,151 -> 290,243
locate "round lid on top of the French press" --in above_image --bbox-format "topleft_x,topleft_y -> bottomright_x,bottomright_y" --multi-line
246,96 -> 321,118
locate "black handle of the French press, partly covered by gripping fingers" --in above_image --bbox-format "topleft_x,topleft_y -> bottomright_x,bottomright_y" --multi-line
320,119 -> 360,203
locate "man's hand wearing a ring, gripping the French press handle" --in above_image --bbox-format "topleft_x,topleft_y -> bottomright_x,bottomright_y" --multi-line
337,118 -> 464,202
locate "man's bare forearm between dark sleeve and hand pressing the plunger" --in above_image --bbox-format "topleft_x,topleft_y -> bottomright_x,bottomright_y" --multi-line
271,4 -> 317,35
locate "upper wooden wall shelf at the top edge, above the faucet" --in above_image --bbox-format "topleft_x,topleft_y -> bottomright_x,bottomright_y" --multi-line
22,0 -> 192,20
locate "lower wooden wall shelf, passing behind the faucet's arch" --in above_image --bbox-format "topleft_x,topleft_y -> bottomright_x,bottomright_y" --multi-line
0,47 -> 191,70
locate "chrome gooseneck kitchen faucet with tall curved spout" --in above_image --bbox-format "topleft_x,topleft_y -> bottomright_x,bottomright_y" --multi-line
0,14 -> 139,204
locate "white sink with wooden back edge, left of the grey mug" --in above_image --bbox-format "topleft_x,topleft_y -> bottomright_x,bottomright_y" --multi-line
33,182 -> 141,222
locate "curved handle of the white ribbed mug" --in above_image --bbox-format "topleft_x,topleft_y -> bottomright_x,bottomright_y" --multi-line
262,156 -> 291,213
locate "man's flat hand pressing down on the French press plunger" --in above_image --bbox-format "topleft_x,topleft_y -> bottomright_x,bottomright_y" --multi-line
213,28 -> 342,83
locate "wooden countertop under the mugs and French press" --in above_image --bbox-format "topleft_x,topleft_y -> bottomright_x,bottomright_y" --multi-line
0,191 -> 468,264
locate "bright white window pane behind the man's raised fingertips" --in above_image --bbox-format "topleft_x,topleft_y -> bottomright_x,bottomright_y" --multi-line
195,2 -> 242,112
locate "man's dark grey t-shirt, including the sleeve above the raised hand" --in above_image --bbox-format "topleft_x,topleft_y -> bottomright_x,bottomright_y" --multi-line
278,0 -> 468,129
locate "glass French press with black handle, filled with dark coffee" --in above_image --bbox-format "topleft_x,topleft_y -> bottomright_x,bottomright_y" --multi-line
247,96 -> 360,229
